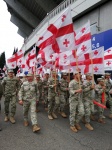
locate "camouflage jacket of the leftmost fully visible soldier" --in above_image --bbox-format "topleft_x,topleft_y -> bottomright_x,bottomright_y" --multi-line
2,77 -> 20,95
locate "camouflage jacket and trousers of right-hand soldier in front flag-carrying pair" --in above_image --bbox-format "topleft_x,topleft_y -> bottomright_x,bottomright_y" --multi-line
83,80 -> 94,123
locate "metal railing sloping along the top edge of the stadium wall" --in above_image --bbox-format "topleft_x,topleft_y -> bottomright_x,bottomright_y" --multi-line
25,0 -> 77,43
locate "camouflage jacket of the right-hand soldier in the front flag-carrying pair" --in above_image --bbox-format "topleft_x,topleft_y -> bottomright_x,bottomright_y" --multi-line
82,80 -> 92,100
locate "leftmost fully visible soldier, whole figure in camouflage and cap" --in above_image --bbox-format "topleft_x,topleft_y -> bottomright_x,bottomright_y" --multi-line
2,69 -> 19,124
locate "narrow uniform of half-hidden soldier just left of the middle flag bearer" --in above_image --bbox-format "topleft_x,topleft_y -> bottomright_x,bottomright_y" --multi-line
42,78 -> 48,108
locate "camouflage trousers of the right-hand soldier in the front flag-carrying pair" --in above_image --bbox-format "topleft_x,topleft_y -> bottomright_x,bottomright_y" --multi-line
83,99 -> 94,123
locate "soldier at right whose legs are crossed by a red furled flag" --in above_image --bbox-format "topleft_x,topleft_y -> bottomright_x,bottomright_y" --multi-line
95,78 -> 105,123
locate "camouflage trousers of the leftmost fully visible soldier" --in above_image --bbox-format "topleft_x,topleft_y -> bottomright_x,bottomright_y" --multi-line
4,94 -> 17,117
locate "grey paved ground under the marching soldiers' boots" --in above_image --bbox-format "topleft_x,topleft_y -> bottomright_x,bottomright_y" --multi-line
0,98 -> 112,150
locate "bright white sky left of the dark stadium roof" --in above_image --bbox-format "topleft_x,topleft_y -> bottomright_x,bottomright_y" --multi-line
0,1 -> 24,58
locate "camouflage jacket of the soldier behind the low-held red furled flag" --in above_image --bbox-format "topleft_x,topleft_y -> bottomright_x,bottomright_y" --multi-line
95,84 -> 104,100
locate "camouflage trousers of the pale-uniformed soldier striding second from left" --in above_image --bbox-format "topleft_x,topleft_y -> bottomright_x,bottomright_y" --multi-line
23,100 -> 37,125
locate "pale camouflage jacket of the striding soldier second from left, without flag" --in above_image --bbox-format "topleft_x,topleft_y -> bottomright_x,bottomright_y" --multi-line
19,81 -> 39,101
